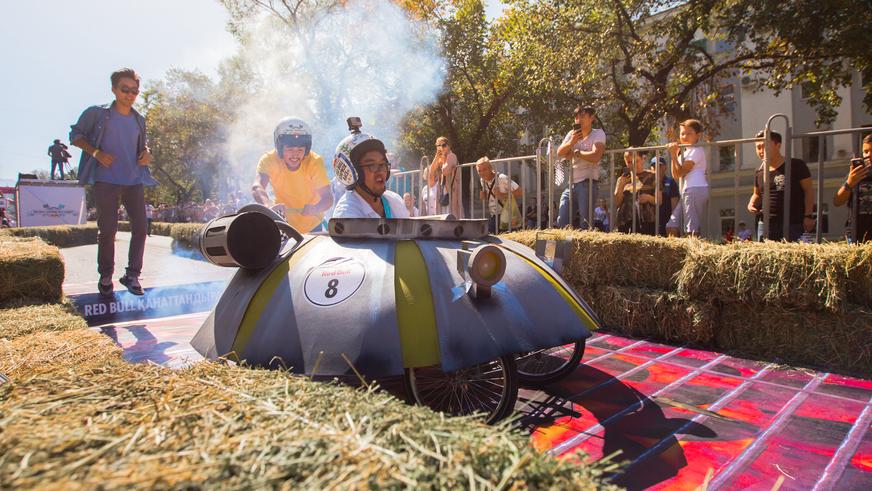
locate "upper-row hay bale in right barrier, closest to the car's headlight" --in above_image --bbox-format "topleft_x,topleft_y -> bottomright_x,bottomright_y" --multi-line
503,229 -> 703,290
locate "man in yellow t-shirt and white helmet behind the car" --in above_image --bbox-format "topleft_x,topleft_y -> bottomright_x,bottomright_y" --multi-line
251,117 -> 333,233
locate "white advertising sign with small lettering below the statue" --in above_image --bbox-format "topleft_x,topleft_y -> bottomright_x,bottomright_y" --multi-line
16,179 -> 88,227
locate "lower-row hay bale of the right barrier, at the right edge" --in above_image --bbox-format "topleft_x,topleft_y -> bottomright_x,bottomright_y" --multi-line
717,304 -> 872,378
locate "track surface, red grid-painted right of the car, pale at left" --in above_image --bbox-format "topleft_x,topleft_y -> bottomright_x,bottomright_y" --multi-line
64,237 -> 872,490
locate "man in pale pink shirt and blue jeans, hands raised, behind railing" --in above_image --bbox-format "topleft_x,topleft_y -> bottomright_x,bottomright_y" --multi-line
557,106 -> 606,228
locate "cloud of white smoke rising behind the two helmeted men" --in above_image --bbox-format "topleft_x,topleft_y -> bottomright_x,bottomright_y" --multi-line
227,0 -> 444,181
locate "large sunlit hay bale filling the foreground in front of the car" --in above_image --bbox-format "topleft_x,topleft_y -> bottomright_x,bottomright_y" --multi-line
0,330 -> 614,490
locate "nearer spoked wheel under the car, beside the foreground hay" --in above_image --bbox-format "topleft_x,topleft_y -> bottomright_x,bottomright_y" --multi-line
403,356 -> 518,423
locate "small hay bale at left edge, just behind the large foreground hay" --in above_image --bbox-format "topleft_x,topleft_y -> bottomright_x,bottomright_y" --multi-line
0,304 -> 88,339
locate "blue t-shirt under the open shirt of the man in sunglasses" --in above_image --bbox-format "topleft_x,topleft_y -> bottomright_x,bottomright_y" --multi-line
95,107 -> 142,186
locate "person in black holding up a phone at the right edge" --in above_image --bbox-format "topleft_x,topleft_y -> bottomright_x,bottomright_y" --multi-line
833,133 -> 872,243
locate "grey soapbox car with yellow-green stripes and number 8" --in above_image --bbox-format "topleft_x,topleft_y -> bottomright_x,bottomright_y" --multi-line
191,205 -> 599,422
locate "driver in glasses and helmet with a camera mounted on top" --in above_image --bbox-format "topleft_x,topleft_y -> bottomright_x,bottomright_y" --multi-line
333,118 -> 409,218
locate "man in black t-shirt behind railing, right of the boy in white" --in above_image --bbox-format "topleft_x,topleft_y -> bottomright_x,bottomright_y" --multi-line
748,131 -> 815,242
